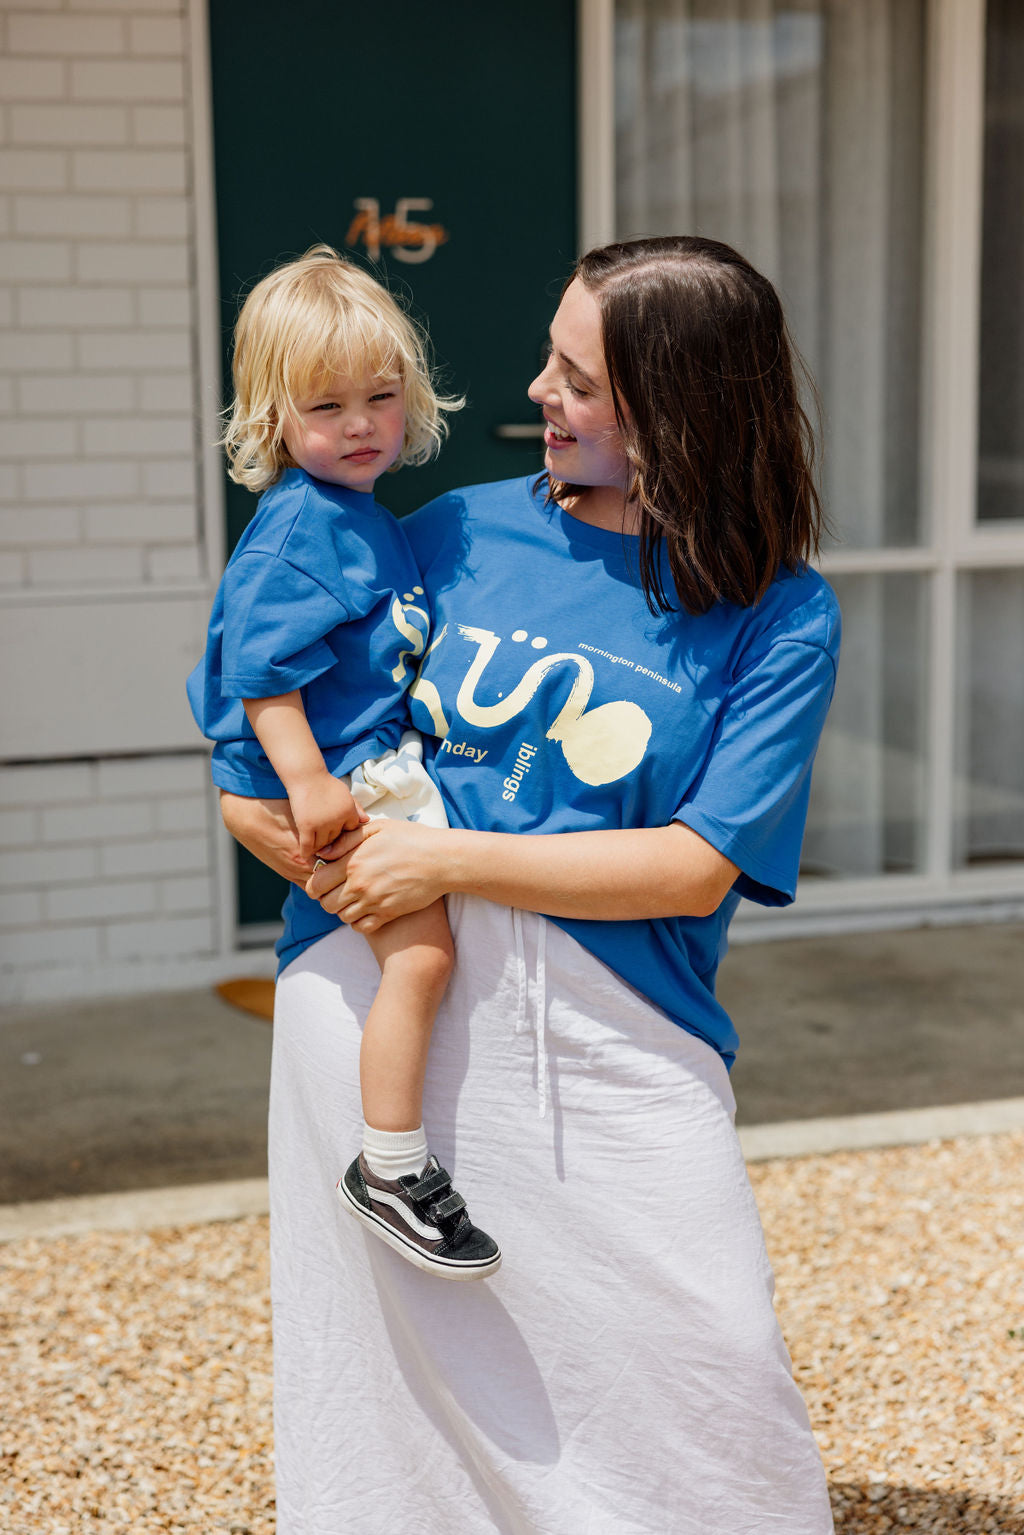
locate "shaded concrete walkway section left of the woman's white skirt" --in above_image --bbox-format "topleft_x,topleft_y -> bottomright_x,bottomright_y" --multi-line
0,990 -> 270,1205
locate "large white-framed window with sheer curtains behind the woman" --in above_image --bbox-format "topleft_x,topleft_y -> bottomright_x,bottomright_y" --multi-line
604,0 -> 1024,909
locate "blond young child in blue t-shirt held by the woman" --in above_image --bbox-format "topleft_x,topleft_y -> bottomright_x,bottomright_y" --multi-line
189,246 -> 500,1279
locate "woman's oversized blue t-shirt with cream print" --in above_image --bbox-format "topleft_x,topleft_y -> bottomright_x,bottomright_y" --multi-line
279,479 -> 840,1062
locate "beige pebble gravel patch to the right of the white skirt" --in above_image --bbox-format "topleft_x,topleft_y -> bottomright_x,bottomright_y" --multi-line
751,1134 -> 1024,1535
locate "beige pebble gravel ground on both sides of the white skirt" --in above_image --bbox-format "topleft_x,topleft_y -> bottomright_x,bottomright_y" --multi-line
0,1134 -> 1024,1535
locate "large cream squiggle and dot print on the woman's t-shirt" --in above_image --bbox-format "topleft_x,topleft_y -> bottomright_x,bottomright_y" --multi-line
410,623 -> 651,786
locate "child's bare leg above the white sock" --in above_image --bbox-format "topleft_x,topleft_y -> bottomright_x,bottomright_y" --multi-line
359,901 -> 454,1131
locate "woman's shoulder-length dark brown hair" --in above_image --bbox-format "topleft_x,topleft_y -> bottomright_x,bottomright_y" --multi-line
551,235 -> 823,612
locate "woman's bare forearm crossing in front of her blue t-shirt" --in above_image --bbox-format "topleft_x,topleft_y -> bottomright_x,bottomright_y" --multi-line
445,823 -> 738,921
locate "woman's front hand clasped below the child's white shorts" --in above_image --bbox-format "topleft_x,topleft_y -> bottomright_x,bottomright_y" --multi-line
306,820 -> 451,933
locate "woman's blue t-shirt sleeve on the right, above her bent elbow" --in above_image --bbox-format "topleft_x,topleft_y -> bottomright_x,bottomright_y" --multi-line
674,639 -> 835,906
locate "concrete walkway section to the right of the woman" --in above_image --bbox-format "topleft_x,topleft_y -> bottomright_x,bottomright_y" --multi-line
718,923 -> 1024,1125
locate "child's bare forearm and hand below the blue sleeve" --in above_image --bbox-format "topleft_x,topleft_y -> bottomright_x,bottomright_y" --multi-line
243,691 -> 367,858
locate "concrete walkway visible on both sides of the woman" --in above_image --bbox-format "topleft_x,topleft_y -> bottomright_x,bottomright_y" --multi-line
0,924 -> 1024,1205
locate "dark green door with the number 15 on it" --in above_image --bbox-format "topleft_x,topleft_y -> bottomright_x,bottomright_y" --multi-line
210,0 -> 576,924
